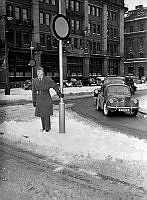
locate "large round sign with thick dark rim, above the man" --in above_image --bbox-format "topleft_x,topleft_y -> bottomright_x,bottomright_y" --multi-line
52,14 -> 70,40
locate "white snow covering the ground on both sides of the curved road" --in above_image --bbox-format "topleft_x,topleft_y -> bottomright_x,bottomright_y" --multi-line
0,84 -> 147,189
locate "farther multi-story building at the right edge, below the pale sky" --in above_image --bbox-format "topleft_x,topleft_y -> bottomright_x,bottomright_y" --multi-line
124,5 -> 147,78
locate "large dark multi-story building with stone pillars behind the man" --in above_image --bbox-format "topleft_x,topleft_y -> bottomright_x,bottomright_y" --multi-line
0,0 -> 126,87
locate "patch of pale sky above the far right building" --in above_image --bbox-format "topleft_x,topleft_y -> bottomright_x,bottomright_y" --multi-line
125,0 -> 147,10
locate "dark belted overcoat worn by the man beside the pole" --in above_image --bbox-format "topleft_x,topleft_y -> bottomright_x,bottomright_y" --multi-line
32,76 -> 60,117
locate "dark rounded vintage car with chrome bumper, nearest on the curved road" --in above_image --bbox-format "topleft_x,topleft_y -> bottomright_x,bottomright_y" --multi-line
96,84 -> 139,116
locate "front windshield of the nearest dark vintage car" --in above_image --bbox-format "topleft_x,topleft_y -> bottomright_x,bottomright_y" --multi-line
108,85 -> 130,95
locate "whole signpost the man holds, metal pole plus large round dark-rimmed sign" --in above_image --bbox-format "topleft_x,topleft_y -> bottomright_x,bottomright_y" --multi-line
51,0 -> 70,133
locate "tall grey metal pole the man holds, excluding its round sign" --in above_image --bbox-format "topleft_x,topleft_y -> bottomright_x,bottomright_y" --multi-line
59,0 -> 65,133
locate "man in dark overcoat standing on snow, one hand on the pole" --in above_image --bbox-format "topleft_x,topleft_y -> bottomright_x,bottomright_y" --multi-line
32,67 -> 64,132
